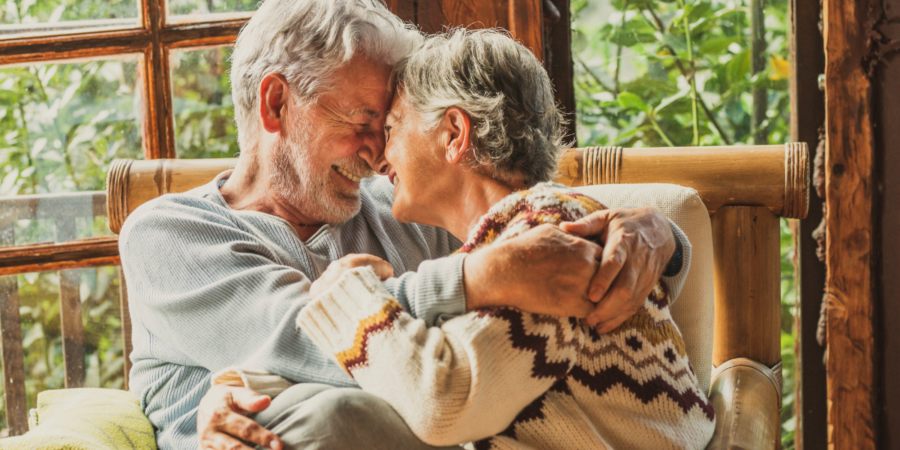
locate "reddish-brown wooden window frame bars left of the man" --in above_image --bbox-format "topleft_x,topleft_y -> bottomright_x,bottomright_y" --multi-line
0,0 -> 253,276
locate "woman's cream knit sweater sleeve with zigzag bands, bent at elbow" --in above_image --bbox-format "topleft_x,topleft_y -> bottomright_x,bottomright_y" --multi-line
297,267 -> 584,445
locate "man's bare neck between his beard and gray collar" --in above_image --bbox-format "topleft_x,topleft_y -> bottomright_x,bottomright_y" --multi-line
219,155 -> 324,241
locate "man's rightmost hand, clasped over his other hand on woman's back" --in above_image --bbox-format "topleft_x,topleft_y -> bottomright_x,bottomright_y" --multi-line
560,207 -> 675,333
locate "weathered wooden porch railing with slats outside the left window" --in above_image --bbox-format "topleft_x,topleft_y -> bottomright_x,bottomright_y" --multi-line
0,191 -> 131,436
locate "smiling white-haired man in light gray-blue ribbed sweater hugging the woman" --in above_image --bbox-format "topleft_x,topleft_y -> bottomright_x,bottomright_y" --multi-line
120,0 -> 687,449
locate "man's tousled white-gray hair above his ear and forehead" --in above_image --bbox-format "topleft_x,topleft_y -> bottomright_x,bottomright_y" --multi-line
231,0 -> 422,148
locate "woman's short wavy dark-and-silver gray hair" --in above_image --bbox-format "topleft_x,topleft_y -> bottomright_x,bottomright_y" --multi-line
394,28 -> 564,186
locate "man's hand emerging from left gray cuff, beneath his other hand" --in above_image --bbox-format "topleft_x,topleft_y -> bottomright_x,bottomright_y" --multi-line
463,225 -> 603,318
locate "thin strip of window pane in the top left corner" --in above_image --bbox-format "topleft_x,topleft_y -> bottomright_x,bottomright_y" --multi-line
0,0 -> 140,39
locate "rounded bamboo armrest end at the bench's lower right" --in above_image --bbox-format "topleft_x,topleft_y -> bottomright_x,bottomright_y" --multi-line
706,358 -> 781,450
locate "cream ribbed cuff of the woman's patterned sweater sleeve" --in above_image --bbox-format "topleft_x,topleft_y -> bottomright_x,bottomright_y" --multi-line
297,266 -> 403,364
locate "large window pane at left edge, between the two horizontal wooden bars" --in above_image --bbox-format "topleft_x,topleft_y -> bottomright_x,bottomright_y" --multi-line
0,57 -> 143,247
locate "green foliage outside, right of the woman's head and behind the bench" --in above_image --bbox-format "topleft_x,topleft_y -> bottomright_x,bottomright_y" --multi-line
571,0 -> 796,449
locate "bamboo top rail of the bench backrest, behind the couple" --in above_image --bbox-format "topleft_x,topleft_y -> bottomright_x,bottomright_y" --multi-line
106,143 -> 809,233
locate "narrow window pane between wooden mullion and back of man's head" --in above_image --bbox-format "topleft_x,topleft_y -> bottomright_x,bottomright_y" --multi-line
169,47 -> 239,158
